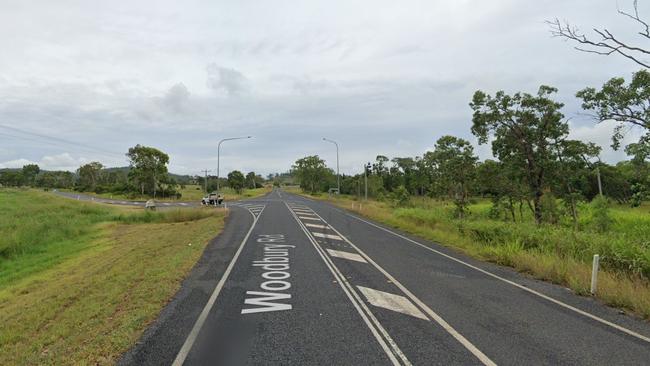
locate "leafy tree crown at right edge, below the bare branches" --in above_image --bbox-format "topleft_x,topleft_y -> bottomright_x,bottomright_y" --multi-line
576,70 -> 650,149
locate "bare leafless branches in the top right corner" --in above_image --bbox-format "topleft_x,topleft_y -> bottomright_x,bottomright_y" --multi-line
546,0 -> 650,68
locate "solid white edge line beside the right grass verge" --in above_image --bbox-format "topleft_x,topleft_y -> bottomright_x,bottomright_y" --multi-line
341,211 -> 650,343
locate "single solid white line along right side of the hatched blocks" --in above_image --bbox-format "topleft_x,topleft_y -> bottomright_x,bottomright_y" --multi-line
306,210 -> 496,366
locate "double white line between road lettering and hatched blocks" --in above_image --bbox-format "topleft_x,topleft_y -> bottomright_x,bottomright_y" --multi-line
285,202 -> 404,366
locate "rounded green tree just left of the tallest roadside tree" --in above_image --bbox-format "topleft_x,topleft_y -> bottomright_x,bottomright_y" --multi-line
430,136 -> 478,219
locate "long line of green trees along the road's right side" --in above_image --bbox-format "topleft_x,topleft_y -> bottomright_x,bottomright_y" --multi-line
292,81 -> 650,225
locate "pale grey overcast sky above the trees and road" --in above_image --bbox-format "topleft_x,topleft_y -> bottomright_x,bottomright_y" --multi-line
0,0 -> 650,174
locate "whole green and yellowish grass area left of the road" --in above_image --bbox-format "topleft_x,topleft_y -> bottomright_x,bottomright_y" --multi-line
0,190 -> 226,365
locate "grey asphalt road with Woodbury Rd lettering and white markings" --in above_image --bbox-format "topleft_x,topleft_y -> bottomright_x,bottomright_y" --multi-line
120,191 -> 650,365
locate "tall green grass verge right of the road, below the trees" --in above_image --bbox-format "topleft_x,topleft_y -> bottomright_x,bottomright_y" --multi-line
293,190 -> 650,319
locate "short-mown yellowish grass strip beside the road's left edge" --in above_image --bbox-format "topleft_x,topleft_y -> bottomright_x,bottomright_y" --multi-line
0,193 -> 225,365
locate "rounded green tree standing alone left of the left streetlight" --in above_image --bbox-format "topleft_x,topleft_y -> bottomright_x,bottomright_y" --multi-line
126,144 -> 169,197
